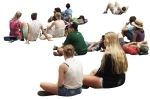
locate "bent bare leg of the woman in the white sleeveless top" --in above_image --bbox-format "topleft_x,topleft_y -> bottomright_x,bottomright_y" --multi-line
40,82 -> 58,95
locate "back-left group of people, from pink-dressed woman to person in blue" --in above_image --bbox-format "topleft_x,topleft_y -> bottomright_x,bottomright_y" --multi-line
4,3 -> 87,43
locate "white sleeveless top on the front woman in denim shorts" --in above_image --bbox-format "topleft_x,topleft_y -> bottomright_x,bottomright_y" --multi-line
64,58 -> 83,89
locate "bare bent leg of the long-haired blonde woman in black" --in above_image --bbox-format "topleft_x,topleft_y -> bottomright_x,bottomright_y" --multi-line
83,75 -> 102,88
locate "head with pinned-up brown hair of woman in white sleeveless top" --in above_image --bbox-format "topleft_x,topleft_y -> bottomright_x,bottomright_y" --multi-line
63,44 -> 75,58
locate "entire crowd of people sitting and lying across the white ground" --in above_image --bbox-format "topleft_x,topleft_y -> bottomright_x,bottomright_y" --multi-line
2,3 -> 149,96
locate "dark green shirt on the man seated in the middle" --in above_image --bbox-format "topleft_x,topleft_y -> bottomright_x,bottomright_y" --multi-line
64,31 -> 87,55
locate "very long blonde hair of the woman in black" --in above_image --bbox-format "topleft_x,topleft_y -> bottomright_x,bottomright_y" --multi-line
102,32 -> 128,74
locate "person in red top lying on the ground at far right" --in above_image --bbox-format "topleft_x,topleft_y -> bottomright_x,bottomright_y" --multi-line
118,33 -> 149,55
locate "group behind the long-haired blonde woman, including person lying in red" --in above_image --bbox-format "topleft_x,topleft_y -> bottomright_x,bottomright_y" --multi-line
84,16 -> 149,55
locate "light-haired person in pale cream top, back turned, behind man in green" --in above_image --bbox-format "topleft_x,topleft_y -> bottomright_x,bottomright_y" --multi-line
47,12 -> 65,37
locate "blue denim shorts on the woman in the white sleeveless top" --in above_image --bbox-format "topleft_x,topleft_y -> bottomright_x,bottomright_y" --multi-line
58,86 -> 82,96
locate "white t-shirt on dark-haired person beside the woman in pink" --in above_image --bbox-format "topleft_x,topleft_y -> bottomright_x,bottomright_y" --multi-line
29,20 -> 42,41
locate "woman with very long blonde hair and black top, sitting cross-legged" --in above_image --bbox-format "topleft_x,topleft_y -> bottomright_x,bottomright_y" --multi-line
83,32 -> 128,88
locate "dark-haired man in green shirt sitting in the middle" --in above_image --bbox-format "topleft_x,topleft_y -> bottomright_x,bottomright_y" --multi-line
53,22 -> 87,56
